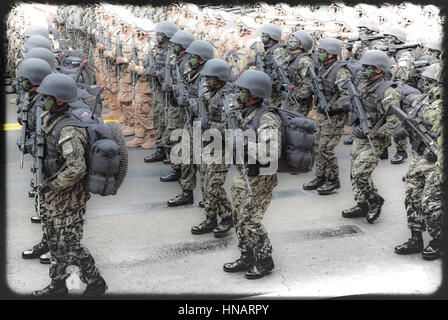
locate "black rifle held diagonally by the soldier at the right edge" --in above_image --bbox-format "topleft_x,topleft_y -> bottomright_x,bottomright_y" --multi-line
389,105 -> 439,162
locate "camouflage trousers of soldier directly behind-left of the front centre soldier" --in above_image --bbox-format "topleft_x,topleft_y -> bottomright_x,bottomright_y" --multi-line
202,164 -> 232,218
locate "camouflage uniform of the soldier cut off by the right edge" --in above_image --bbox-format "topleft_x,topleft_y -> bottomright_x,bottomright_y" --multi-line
405,89 -> 442,239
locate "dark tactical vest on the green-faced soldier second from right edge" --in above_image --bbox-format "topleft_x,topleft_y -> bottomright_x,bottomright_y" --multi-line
353,80 -> 395,139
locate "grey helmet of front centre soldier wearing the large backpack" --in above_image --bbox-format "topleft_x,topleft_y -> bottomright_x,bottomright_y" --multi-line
234,70 -> 272,98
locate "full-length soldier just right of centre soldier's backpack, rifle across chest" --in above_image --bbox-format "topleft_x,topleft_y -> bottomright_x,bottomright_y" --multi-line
303,38 -> 352,195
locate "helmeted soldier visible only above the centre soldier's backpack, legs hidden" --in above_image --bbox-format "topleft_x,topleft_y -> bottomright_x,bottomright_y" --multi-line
288,30 -> 316,116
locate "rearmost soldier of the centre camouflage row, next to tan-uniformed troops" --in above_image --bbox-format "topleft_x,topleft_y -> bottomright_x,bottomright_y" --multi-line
160,30 -> 194,182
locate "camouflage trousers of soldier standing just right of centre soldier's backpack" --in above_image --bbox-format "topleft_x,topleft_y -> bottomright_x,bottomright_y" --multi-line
314,113 -> 346,180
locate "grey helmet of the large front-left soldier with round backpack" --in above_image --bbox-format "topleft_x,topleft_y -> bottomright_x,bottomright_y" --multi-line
37,73 -> 78,103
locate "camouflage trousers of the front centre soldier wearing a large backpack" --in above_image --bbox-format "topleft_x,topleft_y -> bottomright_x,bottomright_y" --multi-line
231,173 -> 277,260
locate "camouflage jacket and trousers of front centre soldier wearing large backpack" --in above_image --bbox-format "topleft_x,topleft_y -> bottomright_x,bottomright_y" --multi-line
231,106 -> 281,260
